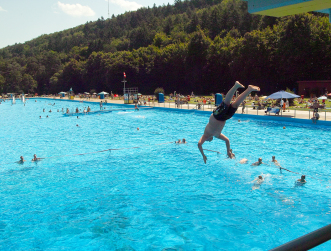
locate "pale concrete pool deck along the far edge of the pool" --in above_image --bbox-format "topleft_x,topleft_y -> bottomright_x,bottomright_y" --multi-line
48,97 -> 331,125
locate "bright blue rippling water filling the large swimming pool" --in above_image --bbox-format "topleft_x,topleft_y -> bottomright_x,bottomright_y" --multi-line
0,99 -> 331,250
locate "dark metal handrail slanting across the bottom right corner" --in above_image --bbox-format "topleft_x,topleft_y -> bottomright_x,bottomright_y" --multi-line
270,224 -> 331,251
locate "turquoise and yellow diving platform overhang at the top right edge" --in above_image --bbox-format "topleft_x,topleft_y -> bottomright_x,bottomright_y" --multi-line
244,0 -> 331,23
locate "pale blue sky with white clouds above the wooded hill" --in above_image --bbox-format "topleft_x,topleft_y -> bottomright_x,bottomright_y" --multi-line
0,0 -> 173,48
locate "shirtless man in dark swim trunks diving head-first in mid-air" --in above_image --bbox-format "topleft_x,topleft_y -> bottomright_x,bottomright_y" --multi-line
198,81 -> 260,164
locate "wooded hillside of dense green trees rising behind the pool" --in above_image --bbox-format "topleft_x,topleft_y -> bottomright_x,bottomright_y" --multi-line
0,0 -> 331,94
